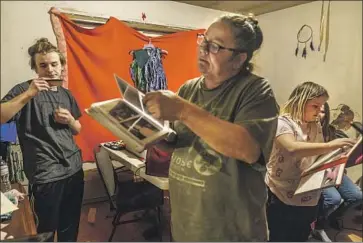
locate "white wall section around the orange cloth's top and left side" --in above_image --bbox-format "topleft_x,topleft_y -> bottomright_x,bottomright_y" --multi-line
1,1 -> 228,97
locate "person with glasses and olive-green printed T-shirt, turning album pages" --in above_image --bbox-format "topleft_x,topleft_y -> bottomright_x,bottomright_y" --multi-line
144,15 -> 278,242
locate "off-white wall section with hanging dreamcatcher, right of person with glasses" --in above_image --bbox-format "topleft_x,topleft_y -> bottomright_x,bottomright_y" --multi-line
256,1 -> 362,115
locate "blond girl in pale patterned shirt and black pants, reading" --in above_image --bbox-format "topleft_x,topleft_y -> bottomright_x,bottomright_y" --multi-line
266,82 -> 355,242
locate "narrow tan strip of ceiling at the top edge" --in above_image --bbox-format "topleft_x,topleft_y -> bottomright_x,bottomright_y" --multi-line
176,1 -> 313,15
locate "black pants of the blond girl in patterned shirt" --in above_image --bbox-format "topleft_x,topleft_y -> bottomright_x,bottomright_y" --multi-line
266,190 -> 317,242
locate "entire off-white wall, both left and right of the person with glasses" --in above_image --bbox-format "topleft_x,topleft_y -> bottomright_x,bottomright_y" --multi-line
1,1 -> 362,180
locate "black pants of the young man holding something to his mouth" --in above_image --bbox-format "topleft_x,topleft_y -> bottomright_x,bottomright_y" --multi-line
29,170 -> 84,242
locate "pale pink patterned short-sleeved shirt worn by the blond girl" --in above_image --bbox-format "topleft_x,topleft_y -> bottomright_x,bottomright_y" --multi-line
265,116 -> 324,206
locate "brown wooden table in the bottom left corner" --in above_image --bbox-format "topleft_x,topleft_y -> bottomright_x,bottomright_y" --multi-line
1,183 -> 37,238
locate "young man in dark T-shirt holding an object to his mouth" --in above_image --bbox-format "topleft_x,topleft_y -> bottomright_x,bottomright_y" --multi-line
0,38 -> 84,241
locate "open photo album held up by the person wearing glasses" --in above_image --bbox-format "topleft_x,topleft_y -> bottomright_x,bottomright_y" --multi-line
86,74 -> 175,153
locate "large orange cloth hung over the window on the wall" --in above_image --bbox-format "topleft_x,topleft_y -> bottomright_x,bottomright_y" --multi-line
50,8 -> 204,161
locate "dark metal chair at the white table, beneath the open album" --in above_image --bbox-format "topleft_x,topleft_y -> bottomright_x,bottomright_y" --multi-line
94,146 -> 164,241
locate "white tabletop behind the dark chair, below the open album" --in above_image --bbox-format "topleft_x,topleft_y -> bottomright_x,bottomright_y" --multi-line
100,143 -> 169,191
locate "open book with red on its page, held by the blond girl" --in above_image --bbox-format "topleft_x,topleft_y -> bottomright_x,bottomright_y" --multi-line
295,137 -> 362,195
